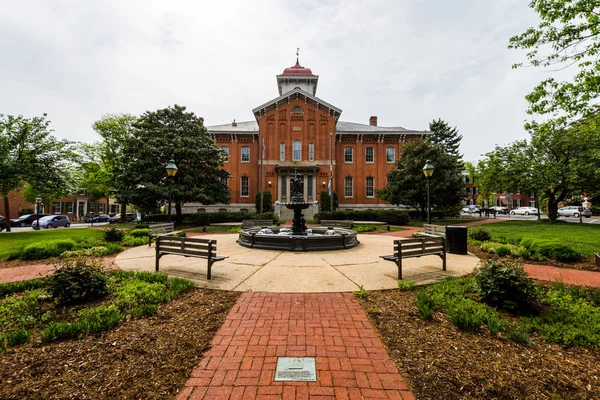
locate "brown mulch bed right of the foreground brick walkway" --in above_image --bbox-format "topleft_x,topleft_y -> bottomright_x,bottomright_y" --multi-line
359,290 -> 600,400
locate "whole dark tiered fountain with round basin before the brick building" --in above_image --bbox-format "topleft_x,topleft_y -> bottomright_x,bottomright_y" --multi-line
238,170 -> 359,251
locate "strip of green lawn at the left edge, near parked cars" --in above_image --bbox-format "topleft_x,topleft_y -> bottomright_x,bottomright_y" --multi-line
0,228 -> 104,258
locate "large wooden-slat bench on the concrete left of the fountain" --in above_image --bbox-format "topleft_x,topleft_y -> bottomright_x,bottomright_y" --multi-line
155,236 -> 228,279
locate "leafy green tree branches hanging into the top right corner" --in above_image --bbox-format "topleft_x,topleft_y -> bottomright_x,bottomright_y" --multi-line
509,0 -> 600,122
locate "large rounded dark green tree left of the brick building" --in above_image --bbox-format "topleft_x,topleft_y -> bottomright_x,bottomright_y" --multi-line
118,105 -> 231,219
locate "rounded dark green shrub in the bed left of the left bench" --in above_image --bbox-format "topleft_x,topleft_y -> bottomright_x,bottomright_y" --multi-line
48,257 -> 107,304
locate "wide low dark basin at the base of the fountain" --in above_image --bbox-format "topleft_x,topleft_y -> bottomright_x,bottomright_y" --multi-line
237,226 -> 359,251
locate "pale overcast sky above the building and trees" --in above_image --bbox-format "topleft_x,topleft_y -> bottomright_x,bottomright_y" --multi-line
0,0 -> 564,161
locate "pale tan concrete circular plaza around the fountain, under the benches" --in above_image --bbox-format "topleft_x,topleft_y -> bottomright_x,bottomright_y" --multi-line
115,232 -> 479,293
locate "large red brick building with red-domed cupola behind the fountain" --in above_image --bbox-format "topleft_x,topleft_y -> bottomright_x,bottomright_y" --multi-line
197,56 -> 431,216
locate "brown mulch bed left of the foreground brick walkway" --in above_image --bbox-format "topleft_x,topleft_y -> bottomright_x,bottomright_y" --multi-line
0,289 -> 240,400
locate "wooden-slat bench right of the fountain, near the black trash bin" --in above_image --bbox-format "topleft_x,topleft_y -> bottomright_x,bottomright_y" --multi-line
379,236 -> 446,280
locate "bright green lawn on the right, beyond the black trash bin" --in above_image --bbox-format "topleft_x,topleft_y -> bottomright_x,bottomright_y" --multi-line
478,220 -> 600,256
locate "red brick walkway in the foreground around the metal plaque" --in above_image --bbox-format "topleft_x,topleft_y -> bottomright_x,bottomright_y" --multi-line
178,292 -> 414,400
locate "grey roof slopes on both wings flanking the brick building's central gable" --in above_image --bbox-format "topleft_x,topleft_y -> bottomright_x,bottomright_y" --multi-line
206,121 -> 431,135
